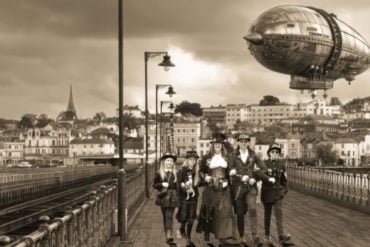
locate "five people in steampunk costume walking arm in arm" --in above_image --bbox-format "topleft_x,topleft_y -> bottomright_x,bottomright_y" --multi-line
153,133 -> 291,246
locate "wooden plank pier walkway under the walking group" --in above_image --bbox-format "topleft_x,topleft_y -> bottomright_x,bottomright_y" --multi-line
117,190 -> 370,247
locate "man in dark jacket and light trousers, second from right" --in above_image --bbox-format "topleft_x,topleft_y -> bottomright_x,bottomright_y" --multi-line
230,133 -> 273,246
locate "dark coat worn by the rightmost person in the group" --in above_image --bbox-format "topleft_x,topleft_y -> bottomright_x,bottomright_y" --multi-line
261,160 -> 288,203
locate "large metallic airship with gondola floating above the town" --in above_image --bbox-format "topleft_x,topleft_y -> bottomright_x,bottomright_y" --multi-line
244,5 -> 370,97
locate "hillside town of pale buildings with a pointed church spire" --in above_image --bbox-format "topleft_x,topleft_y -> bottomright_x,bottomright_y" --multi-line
0,87 -> 370,167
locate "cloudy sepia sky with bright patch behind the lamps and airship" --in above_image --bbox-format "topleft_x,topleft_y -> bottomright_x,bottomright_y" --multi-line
0,0 -> 370,119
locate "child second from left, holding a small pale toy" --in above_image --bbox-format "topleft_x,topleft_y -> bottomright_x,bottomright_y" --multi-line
177,151 -> 199,247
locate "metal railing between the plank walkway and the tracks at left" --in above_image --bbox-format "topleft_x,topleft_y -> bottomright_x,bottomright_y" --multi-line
0,165 -> 155,247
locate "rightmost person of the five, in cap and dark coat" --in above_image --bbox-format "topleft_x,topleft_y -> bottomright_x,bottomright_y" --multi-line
262,143 -> 291,246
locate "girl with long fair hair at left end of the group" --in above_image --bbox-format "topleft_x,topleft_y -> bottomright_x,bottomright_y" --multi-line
153,153 -> 180,246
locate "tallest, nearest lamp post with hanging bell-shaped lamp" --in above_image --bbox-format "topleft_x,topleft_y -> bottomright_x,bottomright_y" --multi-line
144,51 -> 175,198
